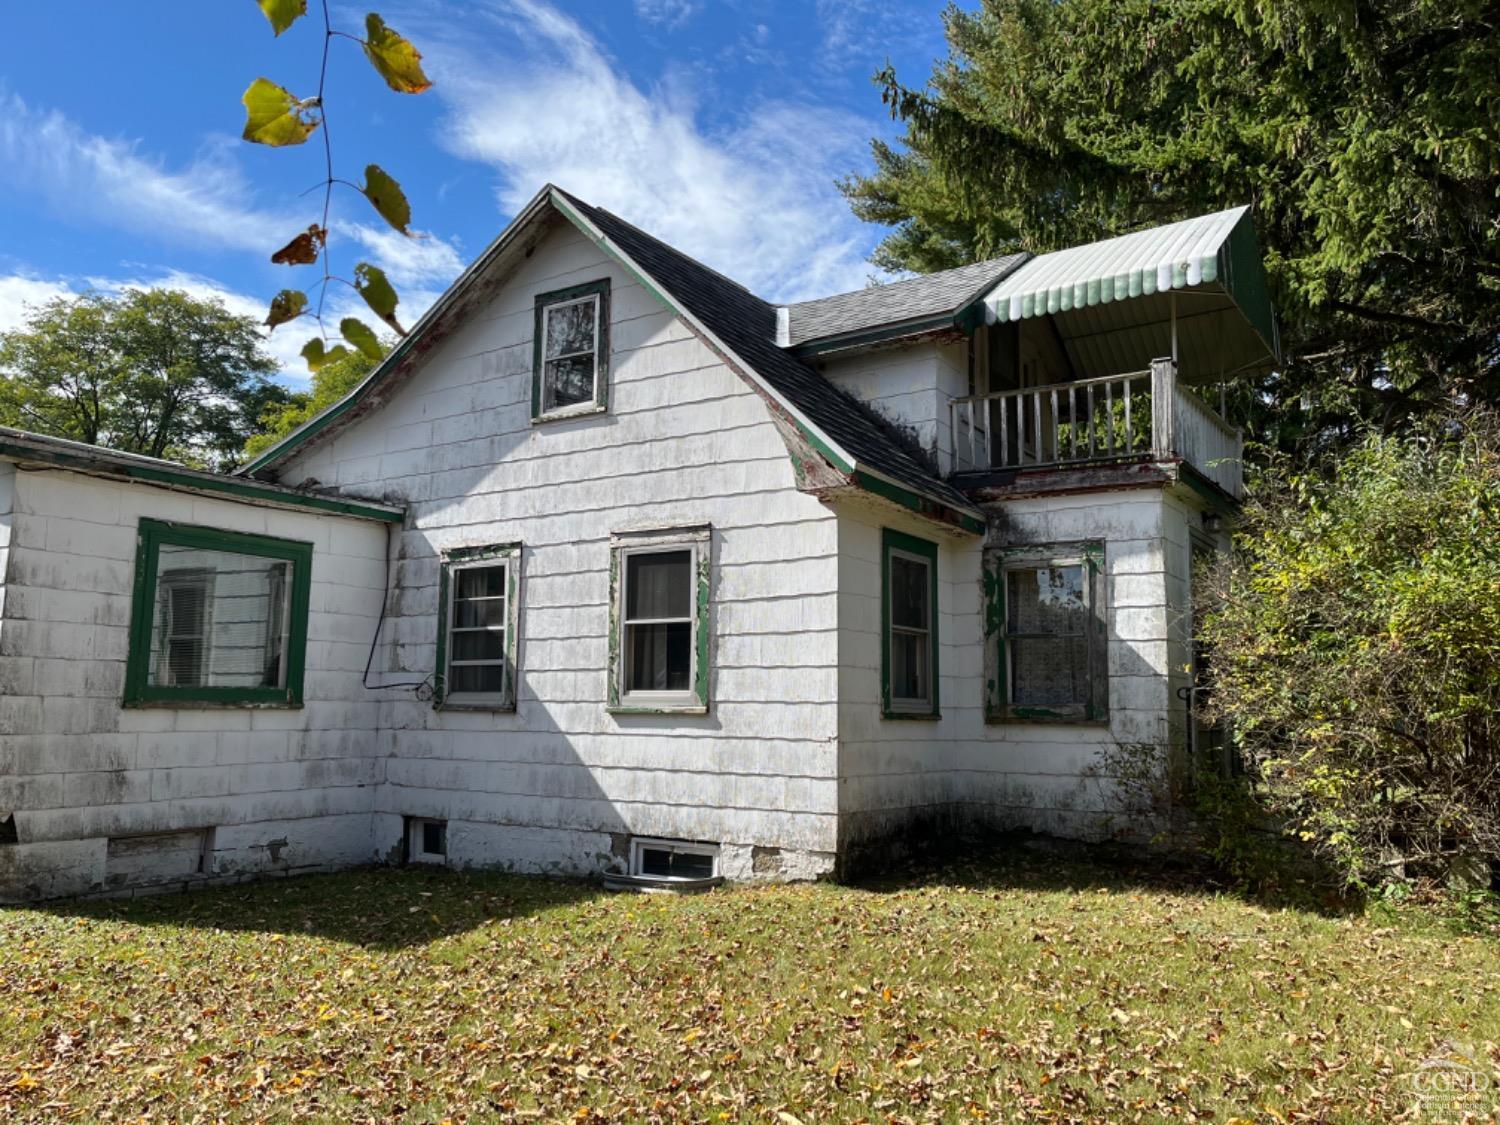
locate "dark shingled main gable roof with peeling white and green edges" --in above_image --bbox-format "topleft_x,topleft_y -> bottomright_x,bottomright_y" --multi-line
249,185 -> 984,531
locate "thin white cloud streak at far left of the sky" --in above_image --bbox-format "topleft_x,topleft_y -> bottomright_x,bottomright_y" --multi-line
0,90 -> 286,252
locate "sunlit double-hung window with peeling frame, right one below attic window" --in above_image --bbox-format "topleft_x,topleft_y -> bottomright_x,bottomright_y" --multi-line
609,528 -> 710,713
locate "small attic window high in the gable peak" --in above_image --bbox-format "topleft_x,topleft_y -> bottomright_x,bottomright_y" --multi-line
531,278 -> 609,422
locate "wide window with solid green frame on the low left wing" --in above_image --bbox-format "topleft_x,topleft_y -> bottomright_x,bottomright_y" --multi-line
125,519 -> 312,707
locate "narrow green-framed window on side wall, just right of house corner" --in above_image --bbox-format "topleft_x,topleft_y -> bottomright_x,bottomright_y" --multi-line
881,528 -> 941,719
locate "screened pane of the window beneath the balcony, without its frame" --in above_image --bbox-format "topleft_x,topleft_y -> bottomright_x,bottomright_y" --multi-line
1005,563 -> 1091,707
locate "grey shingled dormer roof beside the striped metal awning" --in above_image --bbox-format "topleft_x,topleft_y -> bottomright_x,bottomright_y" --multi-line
782,254 -> 1031,351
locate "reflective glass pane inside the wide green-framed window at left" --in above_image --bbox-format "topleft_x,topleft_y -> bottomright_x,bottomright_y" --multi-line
147,543 -> 293,689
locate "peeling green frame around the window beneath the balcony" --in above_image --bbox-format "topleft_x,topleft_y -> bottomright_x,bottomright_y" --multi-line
983,540 -> 1110,726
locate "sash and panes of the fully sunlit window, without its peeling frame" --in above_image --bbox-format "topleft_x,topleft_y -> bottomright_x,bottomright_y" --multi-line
624,551 -> 695,702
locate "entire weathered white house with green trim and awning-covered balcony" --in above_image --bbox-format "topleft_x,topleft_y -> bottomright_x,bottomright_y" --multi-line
0,186 -> 1277,900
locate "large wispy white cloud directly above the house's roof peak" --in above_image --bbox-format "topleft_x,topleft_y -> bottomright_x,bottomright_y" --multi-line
405,0 -> 872,300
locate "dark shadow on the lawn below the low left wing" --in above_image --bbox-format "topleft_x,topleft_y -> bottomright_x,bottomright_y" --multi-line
30,867 -> 605,950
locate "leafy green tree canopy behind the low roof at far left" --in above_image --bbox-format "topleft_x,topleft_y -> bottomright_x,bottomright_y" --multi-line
0,290 -> 290,470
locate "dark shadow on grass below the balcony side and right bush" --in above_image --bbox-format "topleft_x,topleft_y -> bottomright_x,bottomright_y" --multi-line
851,833 -> 1362,918
